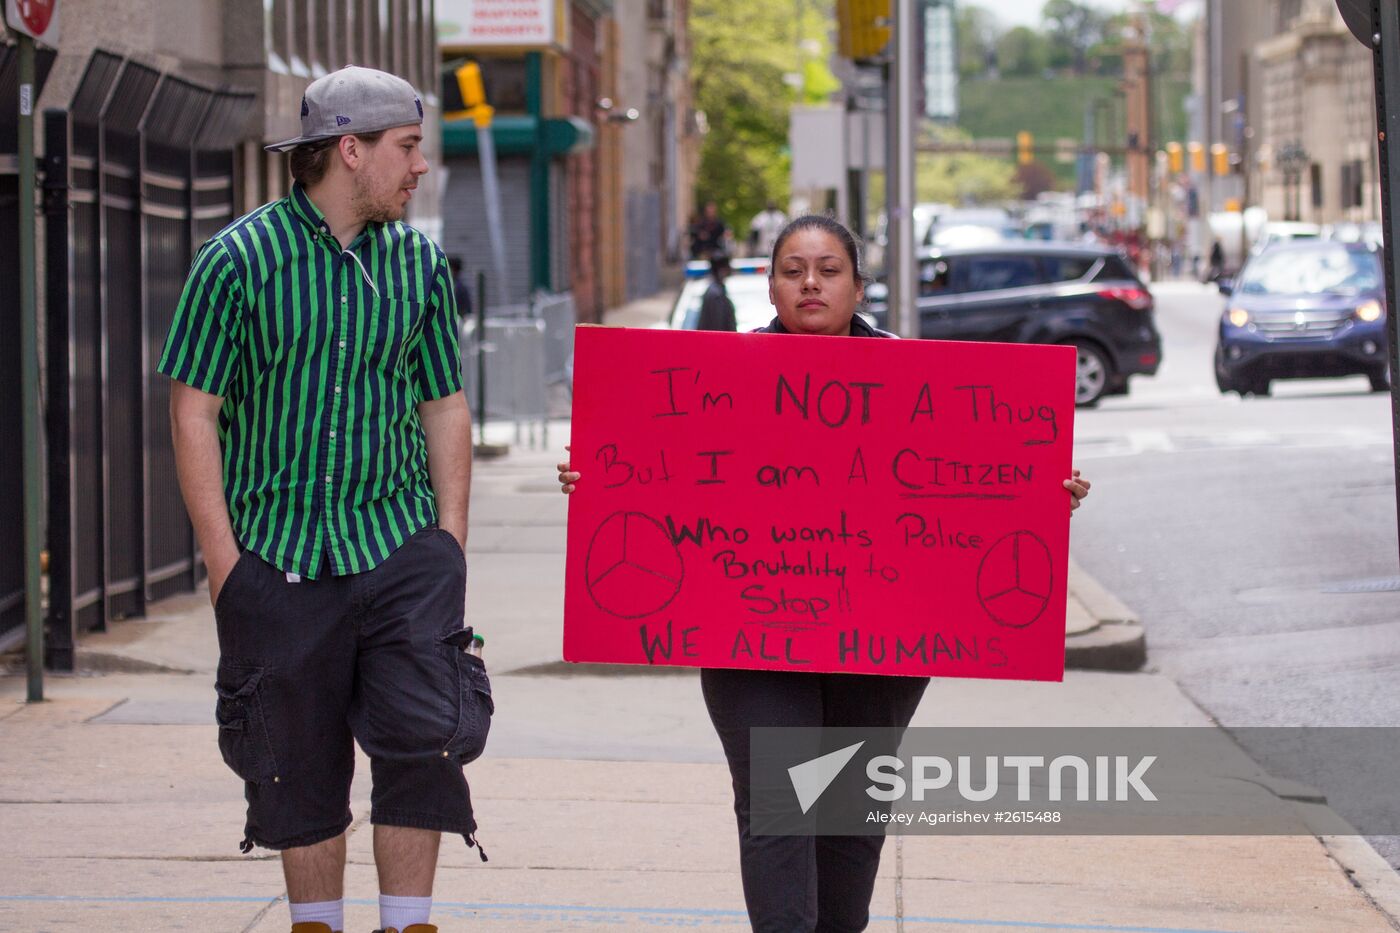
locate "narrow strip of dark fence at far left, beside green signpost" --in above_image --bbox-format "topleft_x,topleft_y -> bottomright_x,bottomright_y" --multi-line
0,43 -> 53,649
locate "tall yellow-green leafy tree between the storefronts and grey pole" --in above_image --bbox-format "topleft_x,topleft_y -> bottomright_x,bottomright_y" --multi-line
690,0 -> 840,231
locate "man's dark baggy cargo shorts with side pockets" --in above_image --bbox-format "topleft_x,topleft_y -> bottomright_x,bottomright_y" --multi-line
214,527 -> 494,852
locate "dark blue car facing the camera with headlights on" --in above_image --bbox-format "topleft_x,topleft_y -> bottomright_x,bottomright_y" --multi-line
1215,240 -> 1390,395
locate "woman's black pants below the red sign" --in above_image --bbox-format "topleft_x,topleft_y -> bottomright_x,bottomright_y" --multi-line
700,670 -> 928,933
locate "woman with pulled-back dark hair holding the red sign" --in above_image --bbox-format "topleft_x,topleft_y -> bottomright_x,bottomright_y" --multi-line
559,216 -> 1089,933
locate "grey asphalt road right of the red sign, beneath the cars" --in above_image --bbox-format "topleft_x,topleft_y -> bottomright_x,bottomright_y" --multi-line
1071,283 -> 1400,867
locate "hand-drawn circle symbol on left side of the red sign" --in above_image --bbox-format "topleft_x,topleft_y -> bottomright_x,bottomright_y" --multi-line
584,511 -> 685,619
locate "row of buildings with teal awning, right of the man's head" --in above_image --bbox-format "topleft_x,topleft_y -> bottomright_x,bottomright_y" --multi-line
438,0 -> 699,322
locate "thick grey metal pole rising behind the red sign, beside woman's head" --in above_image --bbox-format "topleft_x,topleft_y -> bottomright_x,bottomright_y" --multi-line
885,0 -> 918,338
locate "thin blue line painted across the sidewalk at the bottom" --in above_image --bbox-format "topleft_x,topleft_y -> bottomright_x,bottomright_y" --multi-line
0,894 -> 1238,933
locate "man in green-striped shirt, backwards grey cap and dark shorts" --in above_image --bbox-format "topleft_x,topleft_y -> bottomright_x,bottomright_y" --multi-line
160,67 -> 493,933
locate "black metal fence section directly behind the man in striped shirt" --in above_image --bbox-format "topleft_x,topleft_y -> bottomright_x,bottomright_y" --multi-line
45,52 -> 253,670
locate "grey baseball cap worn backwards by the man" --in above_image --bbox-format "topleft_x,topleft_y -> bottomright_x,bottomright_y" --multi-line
266,64 -> 423,153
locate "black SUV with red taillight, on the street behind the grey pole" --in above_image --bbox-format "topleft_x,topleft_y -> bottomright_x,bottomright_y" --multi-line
872,240 -> 1162,405
